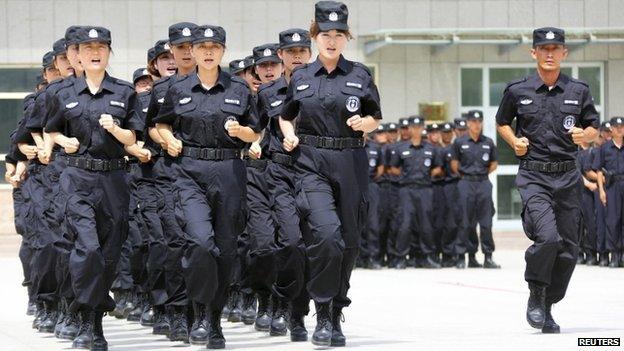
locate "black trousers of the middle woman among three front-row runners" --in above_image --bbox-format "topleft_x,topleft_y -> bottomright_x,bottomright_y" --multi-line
174,157 -> 246,312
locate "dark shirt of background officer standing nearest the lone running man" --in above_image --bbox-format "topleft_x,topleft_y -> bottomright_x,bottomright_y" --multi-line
451,134 -> 498,175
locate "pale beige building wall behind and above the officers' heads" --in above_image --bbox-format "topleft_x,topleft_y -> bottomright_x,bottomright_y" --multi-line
0,0 -> 624,120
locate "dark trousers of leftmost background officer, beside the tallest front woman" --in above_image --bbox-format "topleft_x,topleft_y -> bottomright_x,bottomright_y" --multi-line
360,179 -> 381,259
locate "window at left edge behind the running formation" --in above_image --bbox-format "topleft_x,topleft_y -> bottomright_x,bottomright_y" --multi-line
0,66 -> 41,183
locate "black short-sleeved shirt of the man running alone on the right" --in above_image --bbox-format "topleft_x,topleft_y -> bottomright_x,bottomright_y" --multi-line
496,73 -> 600,162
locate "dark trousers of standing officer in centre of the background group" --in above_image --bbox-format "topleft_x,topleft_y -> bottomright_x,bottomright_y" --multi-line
394,184 -> 436,257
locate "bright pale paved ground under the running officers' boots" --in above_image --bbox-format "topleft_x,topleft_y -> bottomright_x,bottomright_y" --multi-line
0,237 -> 624,351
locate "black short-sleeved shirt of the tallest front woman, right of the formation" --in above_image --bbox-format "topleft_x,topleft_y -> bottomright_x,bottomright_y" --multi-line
281,55 -> 381,138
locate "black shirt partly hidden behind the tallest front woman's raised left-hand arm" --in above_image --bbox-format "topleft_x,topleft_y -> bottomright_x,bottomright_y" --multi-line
257,77 -> 288,157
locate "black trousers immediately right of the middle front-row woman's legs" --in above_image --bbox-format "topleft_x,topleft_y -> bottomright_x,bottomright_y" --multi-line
242,164 -> 276,295
